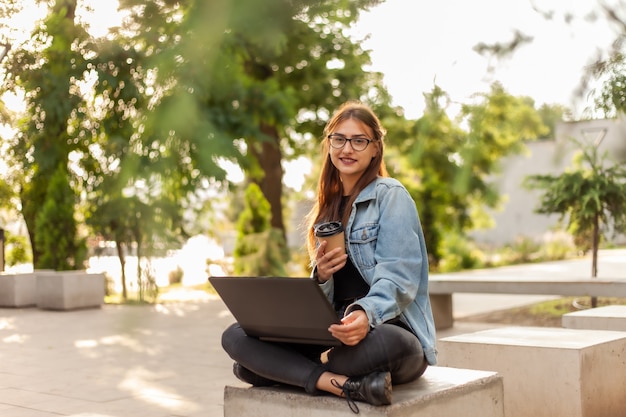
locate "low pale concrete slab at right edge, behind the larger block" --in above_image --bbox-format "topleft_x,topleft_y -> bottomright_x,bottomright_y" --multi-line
561,305 -> 626,332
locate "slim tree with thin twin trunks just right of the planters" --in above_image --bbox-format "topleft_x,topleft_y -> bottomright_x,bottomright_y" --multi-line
78,31 -> 183,301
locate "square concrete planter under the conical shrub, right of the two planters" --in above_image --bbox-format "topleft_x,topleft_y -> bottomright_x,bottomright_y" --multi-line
37,271 -> 105,310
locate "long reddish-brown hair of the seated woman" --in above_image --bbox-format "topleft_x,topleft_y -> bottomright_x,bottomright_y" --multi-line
307,101 -> 389,259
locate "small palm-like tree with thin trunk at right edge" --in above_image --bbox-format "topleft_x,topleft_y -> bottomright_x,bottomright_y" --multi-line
524,139 -> 626,290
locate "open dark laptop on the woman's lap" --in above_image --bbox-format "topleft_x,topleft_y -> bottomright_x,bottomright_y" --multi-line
209,276 -> 341,346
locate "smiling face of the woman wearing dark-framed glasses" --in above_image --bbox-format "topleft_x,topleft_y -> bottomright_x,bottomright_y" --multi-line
327,119 -> 378,195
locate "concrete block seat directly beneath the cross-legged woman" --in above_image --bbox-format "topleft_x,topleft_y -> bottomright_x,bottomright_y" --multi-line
224,366 -> 504,417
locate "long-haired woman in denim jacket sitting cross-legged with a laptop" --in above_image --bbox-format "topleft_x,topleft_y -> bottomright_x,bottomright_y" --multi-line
222,102 -> 437,413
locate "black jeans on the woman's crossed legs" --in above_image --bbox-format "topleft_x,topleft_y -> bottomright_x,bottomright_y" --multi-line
222,323 -> 427,394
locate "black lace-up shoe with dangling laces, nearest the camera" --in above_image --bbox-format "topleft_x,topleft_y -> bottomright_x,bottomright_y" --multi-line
331,372 -> 391,414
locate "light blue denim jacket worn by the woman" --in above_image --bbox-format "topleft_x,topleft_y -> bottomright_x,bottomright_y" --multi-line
320,177 -> 437,365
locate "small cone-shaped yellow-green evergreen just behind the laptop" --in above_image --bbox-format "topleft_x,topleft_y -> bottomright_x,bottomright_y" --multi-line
234,183 -> 289,276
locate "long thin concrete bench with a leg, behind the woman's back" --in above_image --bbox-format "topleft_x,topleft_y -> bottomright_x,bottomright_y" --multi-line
428,275 -> 626,329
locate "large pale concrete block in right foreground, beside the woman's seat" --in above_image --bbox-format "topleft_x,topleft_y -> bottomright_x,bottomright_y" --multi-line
438,327 -> 626,417
